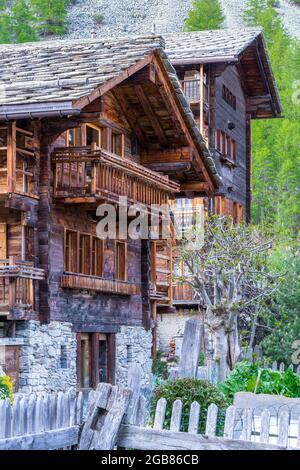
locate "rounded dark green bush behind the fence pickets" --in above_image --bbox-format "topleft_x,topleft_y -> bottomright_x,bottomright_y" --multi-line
151,379 -> 228,432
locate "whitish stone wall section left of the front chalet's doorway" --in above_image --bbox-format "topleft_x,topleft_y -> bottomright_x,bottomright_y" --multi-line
16,320 -> 76,393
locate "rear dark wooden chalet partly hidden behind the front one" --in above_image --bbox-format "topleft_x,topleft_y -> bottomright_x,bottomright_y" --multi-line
159,28 -> 282,349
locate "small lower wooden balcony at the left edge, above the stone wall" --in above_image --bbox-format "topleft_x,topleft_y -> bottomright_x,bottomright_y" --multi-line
0,257 -> 45,319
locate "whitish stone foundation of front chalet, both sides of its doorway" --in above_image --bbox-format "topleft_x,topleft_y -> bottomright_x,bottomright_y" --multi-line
16,320 -> 152,394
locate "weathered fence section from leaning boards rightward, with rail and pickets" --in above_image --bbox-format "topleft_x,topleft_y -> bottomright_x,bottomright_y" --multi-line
79,384 -> 300,450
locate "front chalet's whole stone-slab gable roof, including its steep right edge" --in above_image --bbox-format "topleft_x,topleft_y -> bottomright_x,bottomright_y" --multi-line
0,35 -> 222,186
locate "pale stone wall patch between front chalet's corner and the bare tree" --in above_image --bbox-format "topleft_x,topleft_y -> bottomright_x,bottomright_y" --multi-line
157,310 -> 203,352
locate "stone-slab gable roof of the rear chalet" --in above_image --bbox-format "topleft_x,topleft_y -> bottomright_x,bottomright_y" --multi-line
164,28 -> 282,117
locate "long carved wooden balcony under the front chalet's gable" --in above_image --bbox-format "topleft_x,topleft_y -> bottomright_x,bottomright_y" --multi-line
52,147 -> 179,206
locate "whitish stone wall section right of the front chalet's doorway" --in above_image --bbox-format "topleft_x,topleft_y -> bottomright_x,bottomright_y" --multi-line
116,326 -> 152,393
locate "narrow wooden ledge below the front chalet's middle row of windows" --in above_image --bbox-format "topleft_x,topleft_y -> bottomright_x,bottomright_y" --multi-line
61,273 -> 140,295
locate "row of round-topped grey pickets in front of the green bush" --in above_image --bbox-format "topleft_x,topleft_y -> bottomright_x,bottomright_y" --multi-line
148,398 -> 300,449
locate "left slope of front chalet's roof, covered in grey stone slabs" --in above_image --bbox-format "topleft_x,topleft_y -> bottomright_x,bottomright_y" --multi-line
0,36 -> 164,105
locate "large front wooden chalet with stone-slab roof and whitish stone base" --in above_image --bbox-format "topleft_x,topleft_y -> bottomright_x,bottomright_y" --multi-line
0,36 -> 221,392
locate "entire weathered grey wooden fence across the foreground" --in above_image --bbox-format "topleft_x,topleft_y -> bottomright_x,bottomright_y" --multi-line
0,365 -> 300,450
